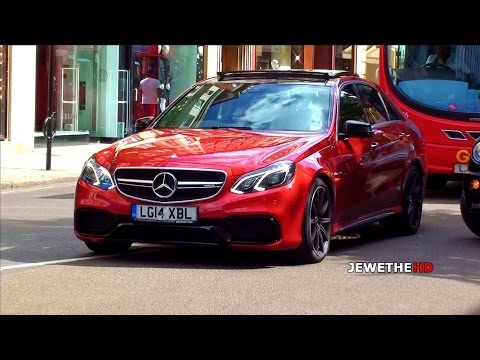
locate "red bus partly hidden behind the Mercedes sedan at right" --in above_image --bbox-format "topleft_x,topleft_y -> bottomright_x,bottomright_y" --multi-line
378,45 -> 480,185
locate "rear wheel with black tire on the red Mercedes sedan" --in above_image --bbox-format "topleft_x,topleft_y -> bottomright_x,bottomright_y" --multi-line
380,166 -> 424,235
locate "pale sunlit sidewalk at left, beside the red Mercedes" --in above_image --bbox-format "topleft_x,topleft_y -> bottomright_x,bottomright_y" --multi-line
0,143 -> 109,190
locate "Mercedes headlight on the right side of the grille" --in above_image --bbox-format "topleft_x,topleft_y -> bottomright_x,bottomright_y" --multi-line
230,161 -> 295,194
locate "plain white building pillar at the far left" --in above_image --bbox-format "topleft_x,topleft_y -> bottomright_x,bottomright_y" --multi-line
2,45 -> 37,153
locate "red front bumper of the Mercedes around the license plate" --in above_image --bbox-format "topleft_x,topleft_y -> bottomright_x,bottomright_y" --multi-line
74,171 -> 311,250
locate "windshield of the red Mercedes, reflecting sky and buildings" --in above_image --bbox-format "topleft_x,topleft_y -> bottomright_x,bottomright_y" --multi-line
154,82 -> 331,132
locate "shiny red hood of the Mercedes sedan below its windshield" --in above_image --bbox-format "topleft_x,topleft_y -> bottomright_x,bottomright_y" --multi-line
96,129 -> 325,174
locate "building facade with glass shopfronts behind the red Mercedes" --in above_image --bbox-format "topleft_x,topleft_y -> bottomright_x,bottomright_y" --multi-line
0,44 -> 378,153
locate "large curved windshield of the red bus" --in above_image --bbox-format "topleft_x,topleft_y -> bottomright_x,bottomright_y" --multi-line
386,45 -> 480,114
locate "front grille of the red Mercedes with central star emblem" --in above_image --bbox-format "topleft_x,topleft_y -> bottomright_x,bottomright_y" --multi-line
115,167 -> 227,204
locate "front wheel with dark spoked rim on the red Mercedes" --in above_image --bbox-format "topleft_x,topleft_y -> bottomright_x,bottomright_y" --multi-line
297,179 -> 333,264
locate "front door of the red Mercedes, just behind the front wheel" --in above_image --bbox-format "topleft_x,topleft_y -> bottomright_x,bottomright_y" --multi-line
334,83 -> 372,228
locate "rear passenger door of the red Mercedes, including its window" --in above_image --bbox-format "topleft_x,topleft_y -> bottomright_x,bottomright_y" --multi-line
356,83 -> 407,212
